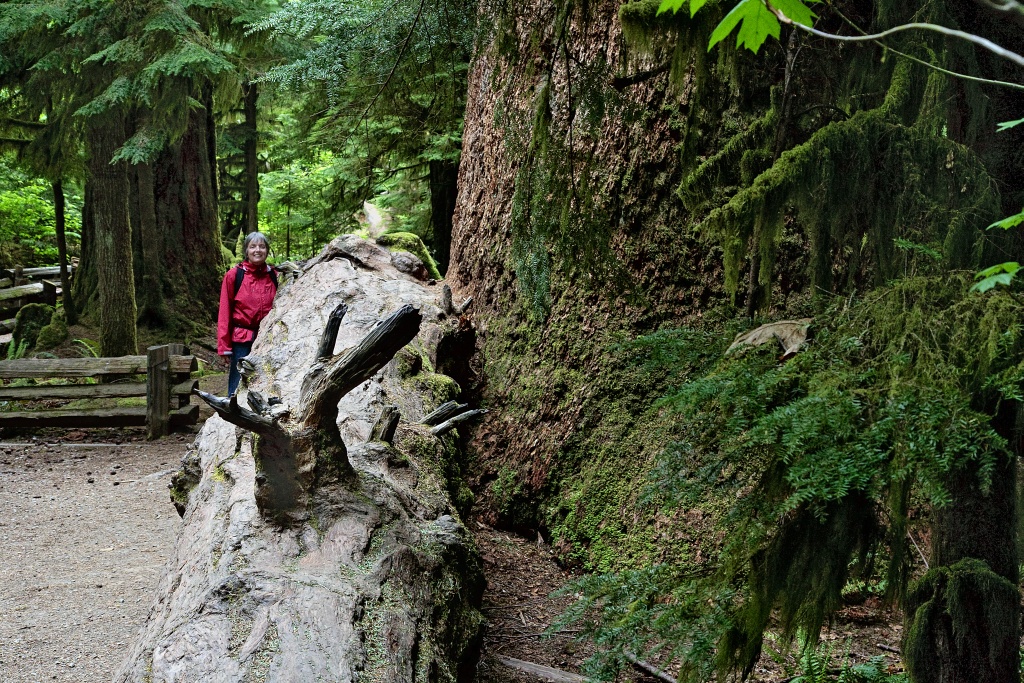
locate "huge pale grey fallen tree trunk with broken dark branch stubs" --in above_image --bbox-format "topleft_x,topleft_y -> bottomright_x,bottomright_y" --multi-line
115,237 -> 482,683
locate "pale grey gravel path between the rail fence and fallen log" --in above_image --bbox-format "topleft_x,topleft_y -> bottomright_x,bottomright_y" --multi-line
0,430 -> 186,683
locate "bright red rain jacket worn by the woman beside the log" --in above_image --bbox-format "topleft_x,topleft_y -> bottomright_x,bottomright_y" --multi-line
217,261 -> 278,355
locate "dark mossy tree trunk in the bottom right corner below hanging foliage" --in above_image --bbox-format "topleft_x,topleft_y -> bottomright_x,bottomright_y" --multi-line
904,405 -> 1021,683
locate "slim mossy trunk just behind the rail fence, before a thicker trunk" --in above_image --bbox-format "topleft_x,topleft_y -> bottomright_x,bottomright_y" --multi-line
86,113 -> 138,356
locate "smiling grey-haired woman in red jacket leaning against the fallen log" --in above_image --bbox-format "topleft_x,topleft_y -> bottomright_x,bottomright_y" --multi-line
217,232 -> 278,396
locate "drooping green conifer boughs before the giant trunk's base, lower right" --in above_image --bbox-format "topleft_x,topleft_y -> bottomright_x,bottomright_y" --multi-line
570,274 -> 1024,680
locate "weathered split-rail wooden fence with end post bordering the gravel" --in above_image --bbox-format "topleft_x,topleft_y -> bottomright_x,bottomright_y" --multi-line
0,344 -> 199,439
